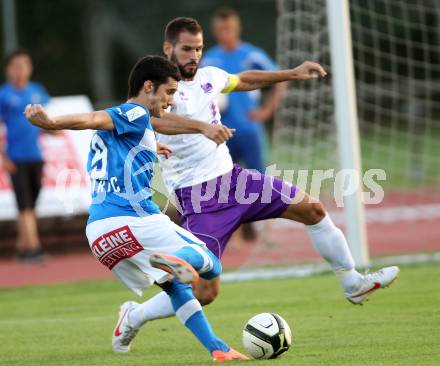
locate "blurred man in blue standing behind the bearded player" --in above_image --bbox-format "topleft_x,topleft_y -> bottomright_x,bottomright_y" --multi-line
202,7 -> 285,239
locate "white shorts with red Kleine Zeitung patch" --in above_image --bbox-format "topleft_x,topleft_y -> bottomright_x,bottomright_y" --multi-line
86,214 -> 206,296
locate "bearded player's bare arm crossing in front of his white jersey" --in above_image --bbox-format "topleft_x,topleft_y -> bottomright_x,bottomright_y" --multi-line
151,113 -> 235,145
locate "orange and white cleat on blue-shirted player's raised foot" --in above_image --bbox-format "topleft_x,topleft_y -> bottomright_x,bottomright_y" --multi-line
150,253 -> 199,286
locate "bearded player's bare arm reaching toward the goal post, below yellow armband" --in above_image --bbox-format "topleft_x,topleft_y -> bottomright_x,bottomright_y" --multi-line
233,61 -> 327,91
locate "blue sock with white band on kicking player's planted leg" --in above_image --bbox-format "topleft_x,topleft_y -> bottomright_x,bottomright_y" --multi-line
163,280 -> 230,353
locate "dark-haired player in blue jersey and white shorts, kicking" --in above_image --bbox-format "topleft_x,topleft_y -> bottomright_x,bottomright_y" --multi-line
25,56 -> 247,362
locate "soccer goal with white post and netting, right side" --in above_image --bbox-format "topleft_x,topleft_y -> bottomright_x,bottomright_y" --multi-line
272,0 -> 440,267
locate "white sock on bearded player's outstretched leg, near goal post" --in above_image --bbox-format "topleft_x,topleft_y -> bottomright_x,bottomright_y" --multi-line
306,215 -> 362,290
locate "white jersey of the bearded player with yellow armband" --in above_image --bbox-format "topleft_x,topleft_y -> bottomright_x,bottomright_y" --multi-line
157,67 -> 233,193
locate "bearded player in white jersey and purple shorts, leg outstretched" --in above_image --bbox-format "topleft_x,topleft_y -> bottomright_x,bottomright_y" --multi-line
123,18 -> 399,332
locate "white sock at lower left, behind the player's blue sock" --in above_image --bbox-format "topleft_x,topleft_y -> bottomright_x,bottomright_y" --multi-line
130,291 -> 175,328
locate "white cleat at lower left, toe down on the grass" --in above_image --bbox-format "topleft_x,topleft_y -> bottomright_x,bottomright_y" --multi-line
112,301 -> 139,353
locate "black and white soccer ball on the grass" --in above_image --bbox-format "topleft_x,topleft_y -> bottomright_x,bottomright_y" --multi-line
243,313 -> 292,359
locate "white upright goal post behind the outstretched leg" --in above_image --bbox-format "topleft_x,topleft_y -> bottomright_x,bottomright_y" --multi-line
327,0 -> 370,268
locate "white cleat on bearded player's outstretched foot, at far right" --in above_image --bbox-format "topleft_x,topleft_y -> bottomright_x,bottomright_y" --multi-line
345,266 -> 400,304
